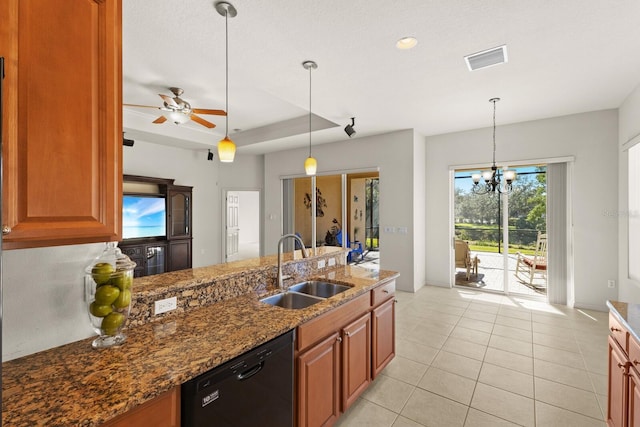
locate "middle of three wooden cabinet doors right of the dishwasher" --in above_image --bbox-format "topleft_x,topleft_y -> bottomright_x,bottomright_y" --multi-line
342,313 -> 371,412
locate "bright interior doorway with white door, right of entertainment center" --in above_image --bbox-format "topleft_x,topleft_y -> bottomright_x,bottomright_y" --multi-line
223,190 -> 260,262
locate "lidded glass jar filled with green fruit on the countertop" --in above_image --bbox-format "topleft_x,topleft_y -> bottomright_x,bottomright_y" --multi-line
85,242 -> 136,348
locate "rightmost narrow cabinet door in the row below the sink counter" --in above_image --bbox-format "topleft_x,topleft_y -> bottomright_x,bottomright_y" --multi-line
372,298 -> 396,378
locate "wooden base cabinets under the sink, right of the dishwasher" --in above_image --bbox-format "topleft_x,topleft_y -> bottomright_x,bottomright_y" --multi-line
296,280 -> 395,427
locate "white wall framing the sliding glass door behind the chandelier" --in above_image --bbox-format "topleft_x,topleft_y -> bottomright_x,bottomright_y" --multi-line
426,110 -> 618,310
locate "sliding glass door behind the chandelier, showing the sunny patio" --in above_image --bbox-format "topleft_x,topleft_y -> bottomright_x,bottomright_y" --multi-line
453,165 -> 548,298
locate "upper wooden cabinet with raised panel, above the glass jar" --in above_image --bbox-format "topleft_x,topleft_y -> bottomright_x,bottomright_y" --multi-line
0,0 -> 122,249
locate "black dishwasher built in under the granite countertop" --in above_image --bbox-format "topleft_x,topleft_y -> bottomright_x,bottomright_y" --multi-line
181,331 -> 294,427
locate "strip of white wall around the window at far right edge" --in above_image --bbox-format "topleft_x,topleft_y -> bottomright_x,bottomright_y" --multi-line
614,82 -> 640,302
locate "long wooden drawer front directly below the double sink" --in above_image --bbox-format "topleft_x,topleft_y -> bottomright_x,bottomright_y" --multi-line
296,293 -> 370,351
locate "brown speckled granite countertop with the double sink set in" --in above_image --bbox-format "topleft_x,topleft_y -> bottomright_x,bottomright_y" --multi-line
2,260 -> 398,427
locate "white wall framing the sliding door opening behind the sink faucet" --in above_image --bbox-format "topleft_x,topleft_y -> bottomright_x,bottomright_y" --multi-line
264,130 -> 424,292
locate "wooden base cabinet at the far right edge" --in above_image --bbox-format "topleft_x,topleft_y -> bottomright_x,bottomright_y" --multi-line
607,314 -> 640,427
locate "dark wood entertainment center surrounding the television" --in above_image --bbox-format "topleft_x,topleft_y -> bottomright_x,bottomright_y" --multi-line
118,175 -> 193,277
